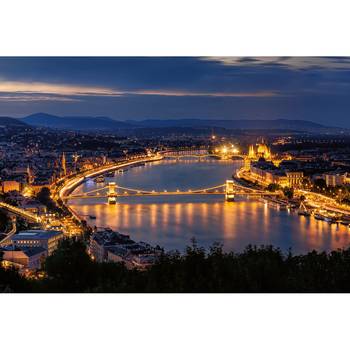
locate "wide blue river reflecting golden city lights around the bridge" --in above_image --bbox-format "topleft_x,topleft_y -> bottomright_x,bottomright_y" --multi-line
69,160 -> 350,253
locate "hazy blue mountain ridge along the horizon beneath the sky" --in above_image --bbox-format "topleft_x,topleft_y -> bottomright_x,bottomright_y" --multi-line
21,113 -> 345,132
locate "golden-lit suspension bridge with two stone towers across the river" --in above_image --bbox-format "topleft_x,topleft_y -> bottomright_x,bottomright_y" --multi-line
63,180 -> 274,204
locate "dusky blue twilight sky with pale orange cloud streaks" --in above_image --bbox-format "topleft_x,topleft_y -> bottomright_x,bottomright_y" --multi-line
0,57 -> 350,127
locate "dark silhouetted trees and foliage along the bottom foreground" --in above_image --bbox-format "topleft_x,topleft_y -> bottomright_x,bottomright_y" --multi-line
0,240 -> 350,293
